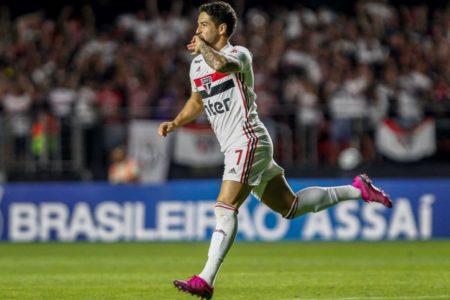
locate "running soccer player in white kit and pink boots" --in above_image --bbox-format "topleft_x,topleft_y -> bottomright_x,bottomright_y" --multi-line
158,1 -> 392,299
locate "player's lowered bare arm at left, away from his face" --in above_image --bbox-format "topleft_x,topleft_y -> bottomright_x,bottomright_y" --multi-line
158,92 -> 204,137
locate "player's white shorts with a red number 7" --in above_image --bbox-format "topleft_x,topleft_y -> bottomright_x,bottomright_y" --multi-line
223,145 -> 284,200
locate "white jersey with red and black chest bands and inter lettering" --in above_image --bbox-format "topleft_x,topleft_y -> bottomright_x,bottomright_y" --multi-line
189,44 -> 272,152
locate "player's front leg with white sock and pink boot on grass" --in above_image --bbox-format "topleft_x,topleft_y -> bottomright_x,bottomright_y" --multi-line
174,180 -> 252,299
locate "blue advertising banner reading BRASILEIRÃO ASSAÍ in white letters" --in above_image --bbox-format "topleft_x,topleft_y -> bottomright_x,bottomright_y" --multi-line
0,179 -> 450,242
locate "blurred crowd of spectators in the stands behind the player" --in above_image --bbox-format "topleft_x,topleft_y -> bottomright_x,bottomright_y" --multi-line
0,0 -> 450,178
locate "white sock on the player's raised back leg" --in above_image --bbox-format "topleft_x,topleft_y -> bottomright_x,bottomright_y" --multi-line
284,185 -> 361,219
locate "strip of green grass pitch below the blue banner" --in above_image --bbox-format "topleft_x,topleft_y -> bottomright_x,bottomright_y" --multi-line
0,241 -> 450,300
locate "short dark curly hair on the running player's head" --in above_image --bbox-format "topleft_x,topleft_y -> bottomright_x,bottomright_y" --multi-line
199,1 -> 237,37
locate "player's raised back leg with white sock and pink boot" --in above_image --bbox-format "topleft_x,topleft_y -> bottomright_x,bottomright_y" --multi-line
261,174 -> 392,219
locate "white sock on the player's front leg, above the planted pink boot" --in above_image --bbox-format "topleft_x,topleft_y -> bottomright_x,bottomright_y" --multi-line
199,202 -> 237,286
